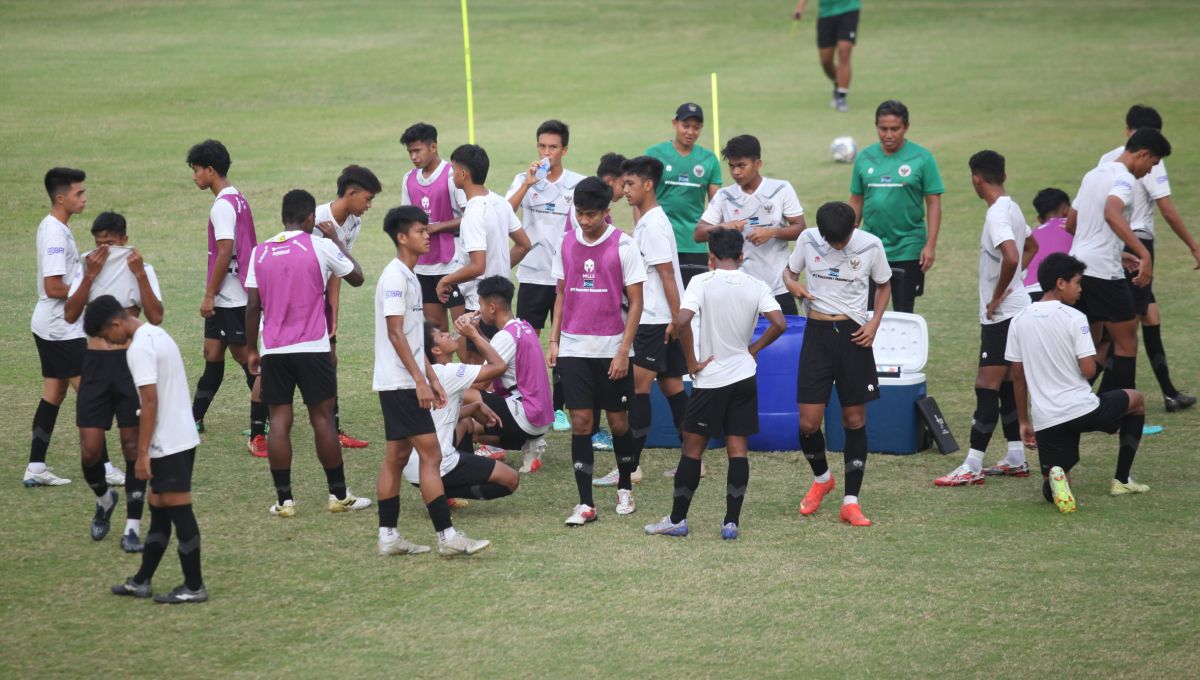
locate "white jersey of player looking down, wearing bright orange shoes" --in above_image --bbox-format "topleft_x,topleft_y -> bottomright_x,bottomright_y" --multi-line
787,227 -> 892,325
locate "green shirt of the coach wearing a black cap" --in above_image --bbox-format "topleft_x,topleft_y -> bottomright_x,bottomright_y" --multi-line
646,140 -> 721,253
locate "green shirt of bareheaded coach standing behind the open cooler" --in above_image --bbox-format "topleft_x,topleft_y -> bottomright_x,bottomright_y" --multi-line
850,140 -> 946,263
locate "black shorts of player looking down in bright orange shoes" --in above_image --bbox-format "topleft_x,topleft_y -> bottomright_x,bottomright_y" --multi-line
796,319 -> 880,407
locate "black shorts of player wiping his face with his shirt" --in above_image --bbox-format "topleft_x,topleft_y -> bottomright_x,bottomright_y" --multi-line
76,349 -> 142,429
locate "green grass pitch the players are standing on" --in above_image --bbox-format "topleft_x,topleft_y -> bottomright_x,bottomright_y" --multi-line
0,0 -> 1200,678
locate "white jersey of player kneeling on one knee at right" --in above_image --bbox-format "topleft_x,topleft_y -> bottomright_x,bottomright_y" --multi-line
1004,300 -> 1100,429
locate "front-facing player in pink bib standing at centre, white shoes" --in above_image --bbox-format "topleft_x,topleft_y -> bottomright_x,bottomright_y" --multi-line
546,177 -> 646,526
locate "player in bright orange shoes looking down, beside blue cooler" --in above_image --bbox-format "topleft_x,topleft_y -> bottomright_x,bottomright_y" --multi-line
784,203 -> 892,526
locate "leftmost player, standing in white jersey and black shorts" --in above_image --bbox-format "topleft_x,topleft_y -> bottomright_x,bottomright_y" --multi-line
22,168 -> 88,487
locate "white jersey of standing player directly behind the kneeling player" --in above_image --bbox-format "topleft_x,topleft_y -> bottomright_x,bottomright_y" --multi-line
1070,163 -> 1138,281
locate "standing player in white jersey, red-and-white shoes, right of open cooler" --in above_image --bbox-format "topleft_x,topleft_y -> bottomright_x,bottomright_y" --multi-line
934,151 -> 1038,487
